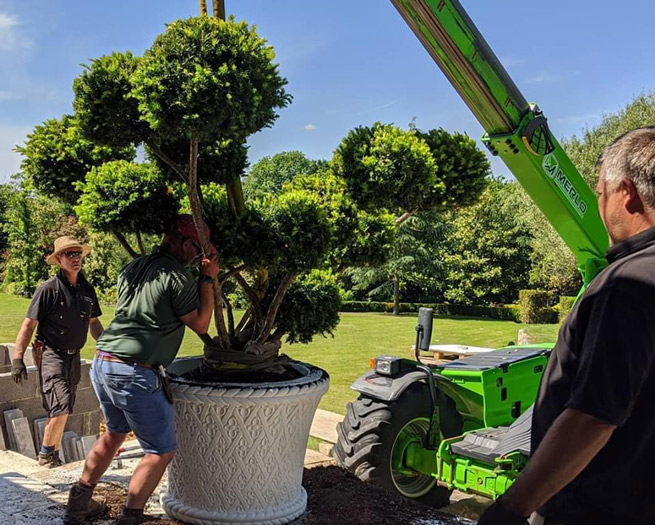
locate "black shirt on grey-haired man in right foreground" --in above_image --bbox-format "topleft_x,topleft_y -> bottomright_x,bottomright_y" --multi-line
532,228 -> 655,525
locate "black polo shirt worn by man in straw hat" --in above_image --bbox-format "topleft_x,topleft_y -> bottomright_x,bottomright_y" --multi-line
27,270 -> 102,350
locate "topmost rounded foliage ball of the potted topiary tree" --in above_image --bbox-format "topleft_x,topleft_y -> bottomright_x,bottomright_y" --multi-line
133,16 -> 290,142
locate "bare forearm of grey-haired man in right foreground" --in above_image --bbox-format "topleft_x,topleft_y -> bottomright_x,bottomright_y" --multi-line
502,408 -> 617,516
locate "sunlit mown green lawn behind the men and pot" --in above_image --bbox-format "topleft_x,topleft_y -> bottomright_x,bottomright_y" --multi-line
0,294 -> 558,413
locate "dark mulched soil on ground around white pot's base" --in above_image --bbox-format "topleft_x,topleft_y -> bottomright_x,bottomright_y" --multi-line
96,466 -> 473,525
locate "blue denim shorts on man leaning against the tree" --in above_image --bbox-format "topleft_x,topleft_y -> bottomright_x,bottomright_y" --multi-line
91,356 -> 177,454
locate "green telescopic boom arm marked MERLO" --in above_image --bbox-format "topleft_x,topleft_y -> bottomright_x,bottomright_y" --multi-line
391,0 -> 608,285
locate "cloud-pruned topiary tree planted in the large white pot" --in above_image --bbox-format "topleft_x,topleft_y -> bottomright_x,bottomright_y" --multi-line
62,11 -> 492,364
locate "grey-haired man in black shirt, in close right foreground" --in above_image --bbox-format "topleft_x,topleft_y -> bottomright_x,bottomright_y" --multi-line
479,127 -> 655,525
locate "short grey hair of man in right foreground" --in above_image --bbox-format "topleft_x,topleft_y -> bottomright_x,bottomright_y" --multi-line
598,126 -> 655,208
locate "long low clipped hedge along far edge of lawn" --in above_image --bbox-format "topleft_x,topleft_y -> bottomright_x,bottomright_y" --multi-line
341,301 -> 520,323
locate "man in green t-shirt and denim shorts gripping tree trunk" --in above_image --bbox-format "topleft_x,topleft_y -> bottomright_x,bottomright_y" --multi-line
64,215 -> 218,525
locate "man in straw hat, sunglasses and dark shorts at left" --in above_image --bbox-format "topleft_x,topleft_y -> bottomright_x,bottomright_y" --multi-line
11,237 -> 102,467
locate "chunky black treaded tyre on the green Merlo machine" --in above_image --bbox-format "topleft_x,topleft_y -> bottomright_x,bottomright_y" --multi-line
333,383 -> 462,507
